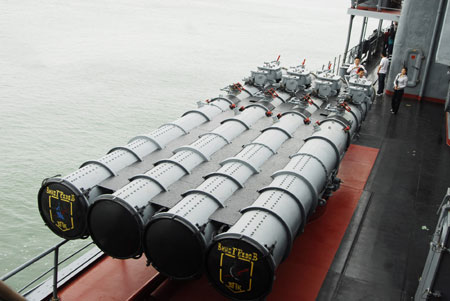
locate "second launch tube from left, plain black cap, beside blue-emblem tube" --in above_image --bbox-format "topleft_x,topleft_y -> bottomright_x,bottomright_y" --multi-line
87,94 -> 282,259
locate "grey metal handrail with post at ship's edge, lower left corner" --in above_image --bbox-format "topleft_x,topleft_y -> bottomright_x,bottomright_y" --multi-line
0,239 -> 98,300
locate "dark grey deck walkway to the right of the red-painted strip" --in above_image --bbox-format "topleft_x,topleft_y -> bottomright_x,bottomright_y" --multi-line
318,90 -> 450,300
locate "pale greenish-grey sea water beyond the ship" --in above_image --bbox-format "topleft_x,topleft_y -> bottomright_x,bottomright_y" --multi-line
0,0 -> 377,287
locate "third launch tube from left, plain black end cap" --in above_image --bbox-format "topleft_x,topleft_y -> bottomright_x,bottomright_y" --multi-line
144,99 -> 322,279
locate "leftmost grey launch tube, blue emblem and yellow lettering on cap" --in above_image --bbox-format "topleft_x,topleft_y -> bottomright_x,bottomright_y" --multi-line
38,91 -> 246,239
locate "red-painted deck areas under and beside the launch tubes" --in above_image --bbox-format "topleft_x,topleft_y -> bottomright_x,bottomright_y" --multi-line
59,145 -> 378,301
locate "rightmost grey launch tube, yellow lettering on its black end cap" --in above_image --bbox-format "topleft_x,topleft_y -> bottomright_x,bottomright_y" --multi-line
206,104 -> 365,300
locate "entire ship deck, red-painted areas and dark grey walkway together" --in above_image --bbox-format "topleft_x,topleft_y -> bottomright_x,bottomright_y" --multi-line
32,63 -> 450,300
